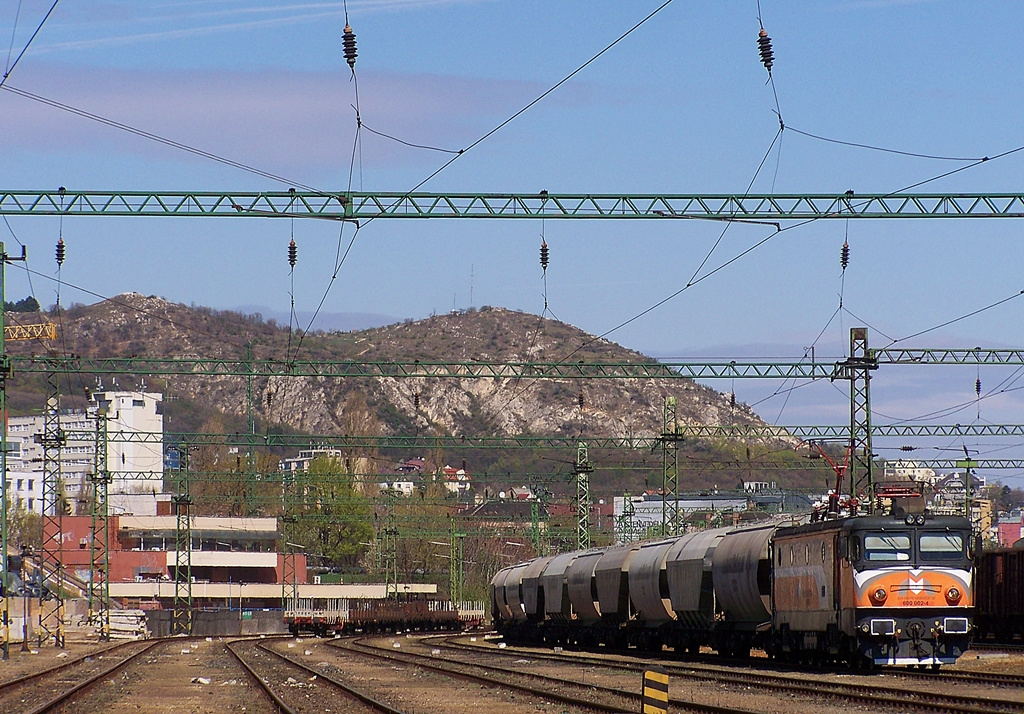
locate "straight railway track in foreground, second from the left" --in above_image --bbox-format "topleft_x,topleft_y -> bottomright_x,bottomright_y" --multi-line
225,640 -> 406,714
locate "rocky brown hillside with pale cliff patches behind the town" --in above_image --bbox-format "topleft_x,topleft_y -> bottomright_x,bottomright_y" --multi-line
2,293 -> 815,493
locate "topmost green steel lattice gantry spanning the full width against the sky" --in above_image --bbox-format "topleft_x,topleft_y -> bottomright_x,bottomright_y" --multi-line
6,188 -> 1024,221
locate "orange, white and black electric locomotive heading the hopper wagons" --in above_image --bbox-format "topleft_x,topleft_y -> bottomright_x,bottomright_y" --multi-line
768,514 -> 974,669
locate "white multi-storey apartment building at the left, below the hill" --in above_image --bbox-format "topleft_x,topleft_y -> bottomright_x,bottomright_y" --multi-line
7,391 -> 164,515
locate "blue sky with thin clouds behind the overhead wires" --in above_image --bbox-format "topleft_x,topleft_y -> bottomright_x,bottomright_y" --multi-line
0,0 -> 1024,479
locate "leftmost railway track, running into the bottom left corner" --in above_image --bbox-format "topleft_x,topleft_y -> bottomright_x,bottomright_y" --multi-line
0,640 -> 163,714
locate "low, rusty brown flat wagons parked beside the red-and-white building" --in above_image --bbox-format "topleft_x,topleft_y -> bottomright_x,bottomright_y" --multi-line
285,594 -> 463,637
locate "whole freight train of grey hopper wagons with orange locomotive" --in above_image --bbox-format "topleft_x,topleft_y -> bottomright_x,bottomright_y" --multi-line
489,514 -> 975,669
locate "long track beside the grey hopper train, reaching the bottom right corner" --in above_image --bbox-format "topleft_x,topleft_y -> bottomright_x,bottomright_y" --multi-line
426,637 -> 1024,714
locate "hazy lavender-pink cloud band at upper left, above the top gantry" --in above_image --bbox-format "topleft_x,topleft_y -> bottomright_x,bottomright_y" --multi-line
0,65 -> 552,182
